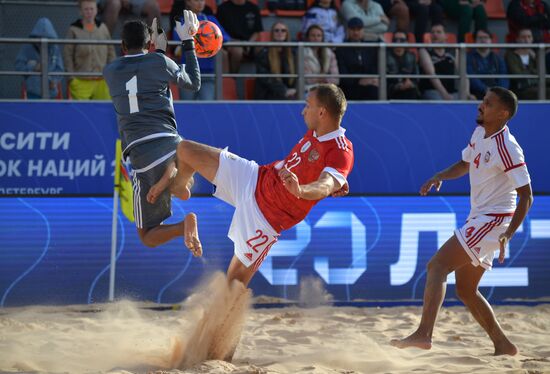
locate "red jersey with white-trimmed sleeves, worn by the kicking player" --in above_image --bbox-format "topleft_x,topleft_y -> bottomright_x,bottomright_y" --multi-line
255,127 -> 353,232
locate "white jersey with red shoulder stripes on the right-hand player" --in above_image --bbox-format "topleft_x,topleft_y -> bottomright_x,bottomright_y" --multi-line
462,126 -> 531,219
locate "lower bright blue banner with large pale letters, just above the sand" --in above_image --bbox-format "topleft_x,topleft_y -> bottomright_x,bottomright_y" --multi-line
0,196 -> 550,306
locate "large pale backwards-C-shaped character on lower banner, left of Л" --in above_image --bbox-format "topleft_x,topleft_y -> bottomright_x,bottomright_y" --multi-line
313,212 -> 367,284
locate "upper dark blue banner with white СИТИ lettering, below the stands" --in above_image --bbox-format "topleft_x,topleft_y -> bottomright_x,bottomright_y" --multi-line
0,102 -> 550,195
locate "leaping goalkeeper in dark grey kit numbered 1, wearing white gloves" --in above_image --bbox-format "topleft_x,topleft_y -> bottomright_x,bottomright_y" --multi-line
103,10 -> 202,256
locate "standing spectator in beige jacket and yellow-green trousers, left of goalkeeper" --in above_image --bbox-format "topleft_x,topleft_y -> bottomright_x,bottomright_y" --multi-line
63,0 -> 116,100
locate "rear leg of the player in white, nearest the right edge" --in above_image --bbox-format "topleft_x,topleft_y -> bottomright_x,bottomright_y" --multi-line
455,265 -> 518,356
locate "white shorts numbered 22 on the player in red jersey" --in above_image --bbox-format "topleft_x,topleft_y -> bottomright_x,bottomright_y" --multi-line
214,149 -> 279,270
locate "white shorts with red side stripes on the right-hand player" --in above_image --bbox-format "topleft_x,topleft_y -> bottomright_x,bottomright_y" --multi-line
455,214 -> 512,270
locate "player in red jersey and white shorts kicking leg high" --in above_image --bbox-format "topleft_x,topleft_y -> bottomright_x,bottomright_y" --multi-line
174,84 -> 353,286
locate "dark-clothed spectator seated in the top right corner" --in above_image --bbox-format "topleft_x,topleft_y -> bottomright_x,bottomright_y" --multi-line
506,0 -> 550,43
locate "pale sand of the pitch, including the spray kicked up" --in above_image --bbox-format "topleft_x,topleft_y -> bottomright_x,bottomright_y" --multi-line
0,274 -> 550,374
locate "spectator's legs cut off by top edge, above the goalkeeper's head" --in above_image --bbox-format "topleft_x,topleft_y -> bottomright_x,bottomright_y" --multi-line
97,0 -> 161,35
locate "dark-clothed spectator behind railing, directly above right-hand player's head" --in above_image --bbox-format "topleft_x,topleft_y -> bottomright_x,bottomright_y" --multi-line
504,29 -> 548,100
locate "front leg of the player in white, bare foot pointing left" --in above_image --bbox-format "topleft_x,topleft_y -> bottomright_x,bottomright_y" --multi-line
390,235 -> 471,349
